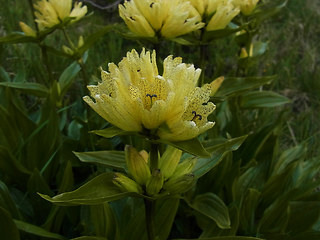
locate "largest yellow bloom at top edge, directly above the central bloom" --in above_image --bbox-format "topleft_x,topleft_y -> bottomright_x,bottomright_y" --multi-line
119,0 -> 204,38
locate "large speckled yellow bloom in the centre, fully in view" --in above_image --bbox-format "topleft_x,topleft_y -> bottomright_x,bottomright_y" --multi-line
84,49 -> 220,141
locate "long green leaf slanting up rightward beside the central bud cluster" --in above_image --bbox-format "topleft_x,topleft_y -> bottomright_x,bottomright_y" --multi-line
193,136 -> 247,178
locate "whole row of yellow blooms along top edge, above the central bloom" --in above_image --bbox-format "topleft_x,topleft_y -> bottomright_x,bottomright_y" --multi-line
119,0 -> 259,38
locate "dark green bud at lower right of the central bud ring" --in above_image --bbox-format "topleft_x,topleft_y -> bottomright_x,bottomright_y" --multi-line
163,173 -> 196,194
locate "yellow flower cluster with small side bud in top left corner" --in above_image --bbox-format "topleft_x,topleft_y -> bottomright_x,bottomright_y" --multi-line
20,0 -> 87,36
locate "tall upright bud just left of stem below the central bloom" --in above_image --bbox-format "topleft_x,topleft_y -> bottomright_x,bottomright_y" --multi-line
125,145 -> 151,185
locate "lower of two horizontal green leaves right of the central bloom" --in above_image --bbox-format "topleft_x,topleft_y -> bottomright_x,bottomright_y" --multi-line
240,91 -> 290,108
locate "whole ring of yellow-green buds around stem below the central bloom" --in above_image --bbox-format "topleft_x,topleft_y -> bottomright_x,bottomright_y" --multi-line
113,146 -> 197,197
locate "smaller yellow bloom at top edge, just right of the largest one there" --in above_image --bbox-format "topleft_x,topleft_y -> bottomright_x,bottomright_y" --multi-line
190,0 -> 240,31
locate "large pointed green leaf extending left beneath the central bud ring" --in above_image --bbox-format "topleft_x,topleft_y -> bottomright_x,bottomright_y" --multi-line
39,173 -> 132,206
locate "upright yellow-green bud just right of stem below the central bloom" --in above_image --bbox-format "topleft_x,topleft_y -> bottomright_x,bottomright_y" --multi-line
159,145 -> 182,179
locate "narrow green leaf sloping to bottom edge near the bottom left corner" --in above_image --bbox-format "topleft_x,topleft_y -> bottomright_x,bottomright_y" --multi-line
14,220 -> 66,240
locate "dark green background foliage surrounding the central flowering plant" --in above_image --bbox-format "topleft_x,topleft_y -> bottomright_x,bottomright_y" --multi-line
0,0 -> 320,240
